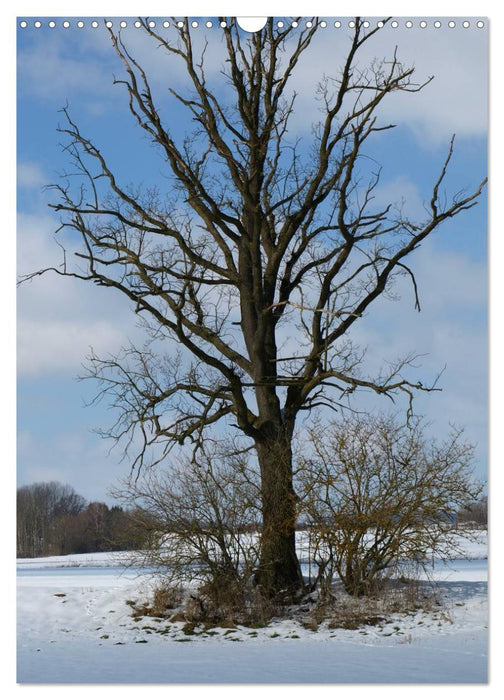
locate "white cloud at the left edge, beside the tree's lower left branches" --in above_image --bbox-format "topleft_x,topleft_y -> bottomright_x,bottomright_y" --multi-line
17,214 -> 138,377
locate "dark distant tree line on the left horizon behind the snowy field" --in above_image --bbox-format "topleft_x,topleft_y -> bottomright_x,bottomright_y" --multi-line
16,481 -> 147,557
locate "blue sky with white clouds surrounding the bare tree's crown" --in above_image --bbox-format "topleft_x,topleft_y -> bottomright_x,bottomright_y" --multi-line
18,13 -> 488,500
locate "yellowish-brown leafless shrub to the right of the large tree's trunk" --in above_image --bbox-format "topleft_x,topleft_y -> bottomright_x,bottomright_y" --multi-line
297,414 -> 482,596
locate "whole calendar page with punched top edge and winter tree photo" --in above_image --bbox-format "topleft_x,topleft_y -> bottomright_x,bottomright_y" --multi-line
16,15 -> 489,684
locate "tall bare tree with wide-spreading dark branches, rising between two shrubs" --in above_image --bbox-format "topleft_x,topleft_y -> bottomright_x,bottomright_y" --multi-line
21,18 -> 484,593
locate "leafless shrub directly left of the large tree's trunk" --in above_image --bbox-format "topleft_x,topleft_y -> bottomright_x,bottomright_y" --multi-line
116,446 -> 273,622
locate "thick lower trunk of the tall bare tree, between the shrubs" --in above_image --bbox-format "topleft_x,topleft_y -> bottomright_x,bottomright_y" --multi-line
256,434 -> 303,598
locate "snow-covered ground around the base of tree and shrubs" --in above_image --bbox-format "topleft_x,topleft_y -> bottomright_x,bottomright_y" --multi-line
17,536 -> 488,683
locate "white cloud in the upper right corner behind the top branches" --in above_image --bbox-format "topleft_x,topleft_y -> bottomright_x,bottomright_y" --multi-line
280,18 -> 488,147
